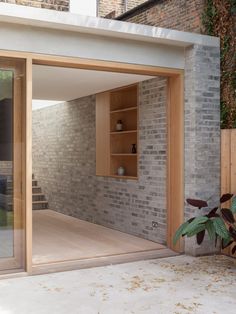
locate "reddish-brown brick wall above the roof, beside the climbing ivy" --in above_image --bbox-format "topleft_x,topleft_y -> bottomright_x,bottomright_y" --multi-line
118,0 -> 205,33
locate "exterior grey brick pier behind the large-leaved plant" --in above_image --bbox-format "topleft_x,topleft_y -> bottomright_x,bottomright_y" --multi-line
185,46 -> 220,255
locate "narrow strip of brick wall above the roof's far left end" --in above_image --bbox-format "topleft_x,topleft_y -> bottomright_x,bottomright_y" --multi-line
0,0 -> 70,11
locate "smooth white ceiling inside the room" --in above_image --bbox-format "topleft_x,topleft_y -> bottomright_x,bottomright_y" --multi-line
33,65 -> 152,101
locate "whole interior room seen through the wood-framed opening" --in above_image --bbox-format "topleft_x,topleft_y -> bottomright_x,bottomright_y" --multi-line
32,65 -> 170,266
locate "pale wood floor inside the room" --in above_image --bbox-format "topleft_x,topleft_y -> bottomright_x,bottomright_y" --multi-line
33,210 -> 165,265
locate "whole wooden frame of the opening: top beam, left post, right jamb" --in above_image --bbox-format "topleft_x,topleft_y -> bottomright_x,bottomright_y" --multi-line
0,50 -> 184,274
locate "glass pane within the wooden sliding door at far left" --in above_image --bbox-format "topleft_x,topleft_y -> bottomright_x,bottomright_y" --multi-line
0,69 -> 14,258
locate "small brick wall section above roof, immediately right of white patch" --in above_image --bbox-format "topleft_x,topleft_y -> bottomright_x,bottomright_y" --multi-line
98,0 -> 146,17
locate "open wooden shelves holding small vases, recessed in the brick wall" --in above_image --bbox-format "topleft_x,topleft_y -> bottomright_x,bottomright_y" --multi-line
110,85 -> 138,179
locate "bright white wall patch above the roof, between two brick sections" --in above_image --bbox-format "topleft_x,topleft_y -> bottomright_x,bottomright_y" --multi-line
70,0 -> 97,16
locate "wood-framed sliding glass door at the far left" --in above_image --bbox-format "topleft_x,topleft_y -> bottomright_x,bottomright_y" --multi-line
0,58 -> 25,273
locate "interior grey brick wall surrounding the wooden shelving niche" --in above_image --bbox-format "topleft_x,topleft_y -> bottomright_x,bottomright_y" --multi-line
33,78 -> 167,243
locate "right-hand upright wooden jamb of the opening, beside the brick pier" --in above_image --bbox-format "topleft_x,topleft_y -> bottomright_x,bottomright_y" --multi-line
167,74 -> 184,252
